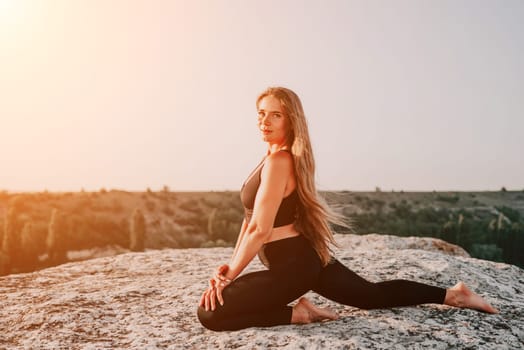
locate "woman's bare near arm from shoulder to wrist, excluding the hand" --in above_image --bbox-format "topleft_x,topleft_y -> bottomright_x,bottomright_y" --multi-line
224,152 -> 293,280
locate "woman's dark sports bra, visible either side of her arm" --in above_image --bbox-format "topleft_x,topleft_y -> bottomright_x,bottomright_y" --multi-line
240,150 -> 298,227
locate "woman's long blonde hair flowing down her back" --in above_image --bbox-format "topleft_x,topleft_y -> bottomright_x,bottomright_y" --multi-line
256,87 -> 348,266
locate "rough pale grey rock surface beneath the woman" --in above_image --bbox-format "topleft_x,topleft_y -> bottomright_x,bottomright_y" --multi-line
0,235 -> 524,349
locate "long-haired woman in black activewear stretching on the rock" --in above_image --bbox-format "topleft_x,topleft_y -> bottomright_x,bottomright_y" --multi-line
198,87 -> 497,331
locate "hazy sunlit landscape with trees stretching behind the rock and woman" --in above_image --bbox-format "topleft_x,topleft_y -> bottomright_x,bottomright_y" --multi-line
0,187 -> 524,275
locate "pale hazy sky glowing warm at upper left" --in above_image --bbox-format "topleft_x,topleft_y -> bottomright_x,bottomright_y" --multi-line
0,0 -> 524,191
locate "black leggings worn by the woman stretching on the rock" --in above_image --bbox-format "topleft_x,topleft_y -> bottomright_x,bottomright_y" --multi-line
198,236 -> 446,331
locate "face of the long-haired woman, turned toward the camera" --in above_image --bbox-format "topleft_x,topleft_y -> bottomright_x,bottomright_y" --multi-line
258,95 -> 288,145
